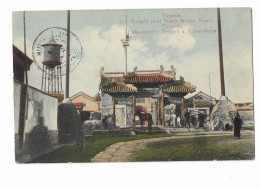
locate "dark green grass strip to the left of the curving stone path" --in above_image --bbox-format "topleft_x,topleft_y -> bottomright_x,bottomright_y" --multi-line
30,131 -> 170,163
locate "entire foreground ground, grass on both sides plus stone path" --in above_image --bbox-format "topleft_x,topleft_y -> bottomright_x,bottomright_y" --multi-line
30,131 -> 254,163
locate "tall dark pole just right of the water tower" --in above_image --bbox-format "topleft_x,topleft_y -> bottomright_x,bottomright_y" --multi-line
65,10 -> 70,98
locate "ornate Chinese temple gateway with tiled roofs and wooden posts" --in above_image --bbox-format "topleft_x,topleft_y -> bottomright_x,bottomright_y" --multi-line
100,69 -> 196,129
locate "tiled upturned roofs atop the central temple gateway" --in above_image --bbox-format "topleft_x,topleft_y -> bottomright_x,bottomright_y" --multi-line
100,70 -> 196,96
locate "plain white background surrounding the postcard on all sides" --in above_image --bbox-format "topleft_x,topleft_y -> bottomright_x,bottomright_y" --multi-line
0,0 -> 260,189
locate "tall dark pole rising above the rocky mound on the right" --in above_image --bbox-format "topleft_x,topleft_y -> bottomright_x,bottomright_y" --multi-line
218,8 -> 226,96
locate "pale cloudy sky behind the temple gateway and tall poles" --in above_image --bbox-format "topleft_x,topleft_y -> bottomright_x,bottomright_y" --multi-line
13,8 -> 253,102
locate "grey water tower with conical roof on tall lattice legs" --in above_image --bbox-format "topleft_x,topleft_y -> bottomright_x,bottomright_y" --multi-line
42,34 -> 63,102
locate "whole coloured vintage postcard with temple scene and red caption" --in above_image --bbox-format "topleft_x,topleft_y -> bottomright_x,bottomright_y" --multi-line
12,8 -> 255,163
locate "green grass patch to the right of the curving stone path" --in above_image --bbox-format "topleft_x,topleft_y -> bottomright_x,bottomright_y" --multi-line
131,135 -> 255,161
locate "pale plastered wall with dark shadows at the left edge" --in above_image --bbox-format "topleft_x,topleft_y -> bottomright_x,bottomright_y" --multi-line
14,81 -> 58,162
